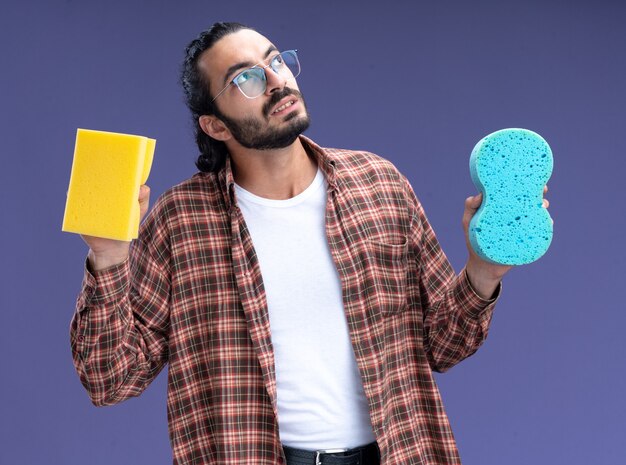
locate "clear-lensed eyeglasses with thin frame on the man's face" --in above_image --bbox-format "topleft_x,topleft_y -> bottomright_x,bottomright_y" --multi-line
211,50 -> 300,102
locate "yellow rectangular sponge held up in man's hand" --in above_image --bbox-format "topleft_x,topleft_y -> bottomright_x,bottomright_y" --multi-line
62,129 -> 156,241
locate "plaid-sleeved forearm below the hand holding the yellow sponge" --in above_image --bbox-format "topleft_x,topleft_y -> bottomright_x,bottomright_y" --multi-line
70,254 -> 166,406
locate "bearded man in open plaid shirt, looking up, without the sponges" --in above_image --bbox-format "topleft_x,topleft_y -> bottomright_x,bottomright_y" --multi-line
71,23 -> 544,465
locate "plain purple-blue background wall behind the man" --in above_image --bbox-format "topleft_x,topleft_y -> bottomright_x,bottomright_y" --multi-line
0,0 -> 626,465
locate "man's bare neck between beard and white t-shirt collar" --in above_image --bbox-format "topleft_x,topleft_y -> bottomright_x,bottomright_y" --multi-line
229,139 -> 317,200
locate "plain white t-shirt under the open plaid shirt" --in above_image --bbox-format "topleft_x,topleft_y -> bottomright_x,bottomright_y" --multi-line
235,170 -> 375,450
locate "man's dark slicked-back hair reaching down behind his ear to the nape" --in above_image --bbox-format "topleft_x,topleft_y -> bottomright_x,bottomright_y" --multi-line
181,22 -> 251,172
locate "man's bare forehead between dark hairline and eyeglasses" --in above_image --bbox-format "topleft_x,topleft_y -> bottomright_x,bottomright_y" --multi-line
198,29 -> 272,89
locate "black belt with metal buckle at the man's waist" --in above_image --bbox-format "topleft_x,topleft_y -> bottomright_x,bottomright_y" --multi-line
283,442 -> 380,465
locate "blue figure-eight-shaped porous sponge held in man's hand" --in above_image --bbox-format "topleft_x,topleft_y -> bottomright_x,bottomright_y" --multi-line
469,129 -> 553,265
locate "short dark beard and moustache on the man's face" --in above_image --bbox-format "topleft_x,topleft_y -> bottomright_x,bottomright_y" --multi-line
215,87 -> 311,150
